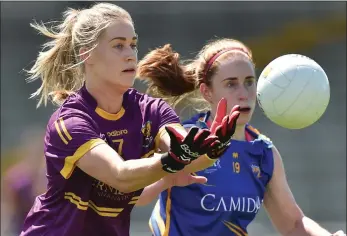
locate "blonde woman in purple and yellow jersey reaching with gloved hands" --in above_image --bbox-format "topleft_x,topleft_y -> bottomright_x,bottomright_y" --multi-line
21,3 -> 239,236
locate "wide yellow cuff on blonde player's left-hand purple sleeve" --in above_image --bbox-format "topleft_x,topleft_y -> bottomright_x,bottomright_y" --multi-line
60,138 -> 105,179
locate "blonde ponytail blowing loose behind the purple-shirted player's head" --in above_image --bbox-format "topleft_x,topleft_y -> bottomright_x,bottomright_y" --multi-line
27,9 -> 83,107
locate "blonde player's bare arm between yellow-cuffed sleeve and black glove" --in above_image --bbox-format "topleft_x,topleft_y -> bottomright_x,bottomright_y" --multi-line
76,144 -> 168,193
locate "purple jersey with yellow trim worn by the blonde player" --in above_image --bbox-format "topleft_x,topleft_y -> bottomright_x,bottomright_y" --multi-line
21,87 -> 180,236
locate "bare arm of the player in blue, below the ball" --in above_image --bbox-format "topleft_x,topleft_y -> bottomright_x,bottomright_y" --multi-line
264,147 -> 332,236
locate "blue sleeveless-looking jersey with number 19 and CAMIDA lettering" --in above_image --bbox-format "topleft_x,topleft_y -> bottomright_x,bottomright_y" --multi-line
149,113 -> 274,236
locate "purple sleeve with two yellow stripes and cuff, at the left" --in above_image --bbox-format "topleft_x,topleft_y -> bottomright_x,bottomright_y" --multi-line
45,115 -> 105,179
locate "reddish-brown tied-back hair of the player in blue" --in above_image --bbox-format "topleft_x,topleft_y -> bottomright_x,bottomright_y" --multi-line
137,39 -> 253,109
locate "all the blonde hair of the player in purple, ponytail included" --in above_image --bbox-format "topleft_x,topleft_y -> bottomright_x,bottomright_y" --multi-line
27,3 -> 132,107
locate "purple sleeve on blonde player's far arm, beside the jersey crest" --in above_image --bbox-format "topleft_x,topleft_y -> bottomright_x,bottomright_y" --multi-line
155,100 -> 185,147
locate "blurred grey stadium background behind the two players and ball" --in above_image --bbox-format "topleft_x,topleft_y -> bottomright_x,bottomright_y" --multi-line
1,2 -> 346,236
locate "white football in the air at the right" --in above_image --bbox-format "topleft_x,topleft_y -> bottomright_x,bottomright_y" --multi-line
257,54 -> 330,129
